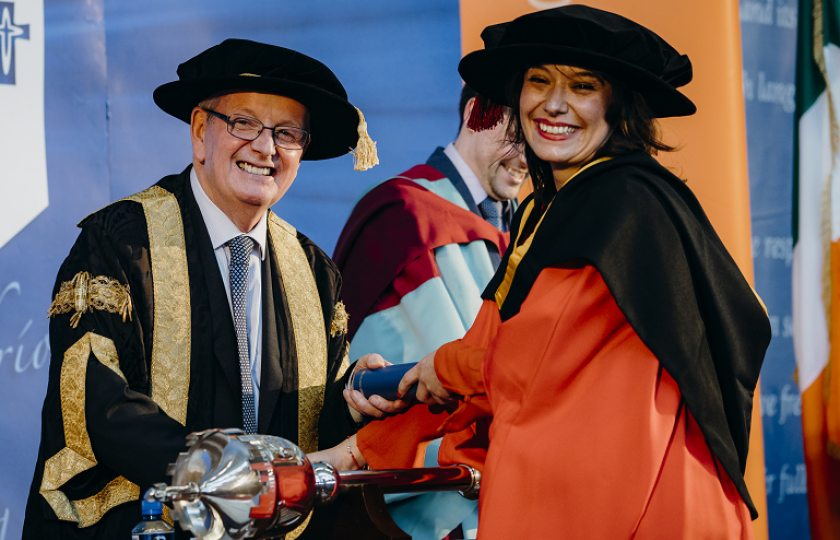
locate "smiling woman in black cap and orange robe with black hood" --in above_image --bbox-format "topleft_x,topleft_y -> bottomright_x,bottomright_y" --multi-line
342,5 -> 770,539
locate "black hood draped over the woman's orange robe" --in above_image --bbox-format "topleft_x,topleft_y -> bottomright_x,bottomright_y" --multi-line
483,153 -> 770,518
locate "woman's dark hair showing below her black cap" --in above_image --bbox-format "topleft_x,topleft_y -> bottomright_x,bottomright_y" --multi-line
507,66 -> 676,212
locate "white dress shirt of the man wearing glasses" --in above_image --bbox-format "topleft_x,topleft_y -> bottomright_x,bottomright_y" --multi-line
190,169 -> 268,420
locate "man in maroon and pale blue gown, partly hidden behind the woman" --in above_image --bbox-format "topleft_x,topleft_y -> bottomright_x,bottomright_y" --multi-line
335,86 -> 528,540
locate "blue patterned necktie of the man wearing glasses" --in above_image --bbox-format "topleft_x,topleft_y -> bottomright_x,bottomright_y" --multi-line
227,236 -> 257,433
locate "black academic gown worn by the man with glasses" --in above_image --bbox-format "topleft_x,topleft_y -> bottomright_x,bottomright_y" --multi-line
23,168 -> 355,540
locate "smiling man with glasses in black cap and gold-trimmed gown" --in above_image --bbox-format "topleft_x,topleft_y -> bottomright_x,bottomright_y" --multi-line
23,40 -> 371,540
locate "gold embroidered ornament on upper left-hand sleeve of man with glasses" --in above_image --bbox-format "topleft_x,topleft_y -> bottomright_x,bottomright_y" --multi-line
47,272 -> 132,328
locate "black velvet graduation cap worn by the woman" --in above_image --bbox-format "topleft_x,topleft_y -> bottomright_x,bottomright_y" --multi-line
458,4 -> 697,127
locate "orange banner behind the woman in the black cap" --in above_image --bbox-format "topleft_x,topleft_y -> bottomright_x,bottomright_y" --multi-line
461,0 -> 768,539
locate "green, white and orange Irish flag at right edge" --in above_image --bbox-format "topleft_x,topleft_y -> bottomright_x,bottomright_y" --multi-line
793,0 -> 840,540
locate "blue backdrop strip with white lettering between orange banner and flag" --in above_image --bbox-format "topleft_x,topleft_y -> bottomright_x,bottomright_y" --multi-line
740,0 -> 810,540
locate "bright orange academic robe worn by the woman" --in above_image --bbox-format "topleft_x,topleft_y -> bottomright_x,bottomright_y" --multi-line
358,266 -> 752,540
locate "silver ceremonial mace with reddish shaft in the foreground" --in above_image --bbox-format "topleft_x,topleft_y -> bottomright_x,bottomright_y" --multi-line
145,429 -> 481,540
